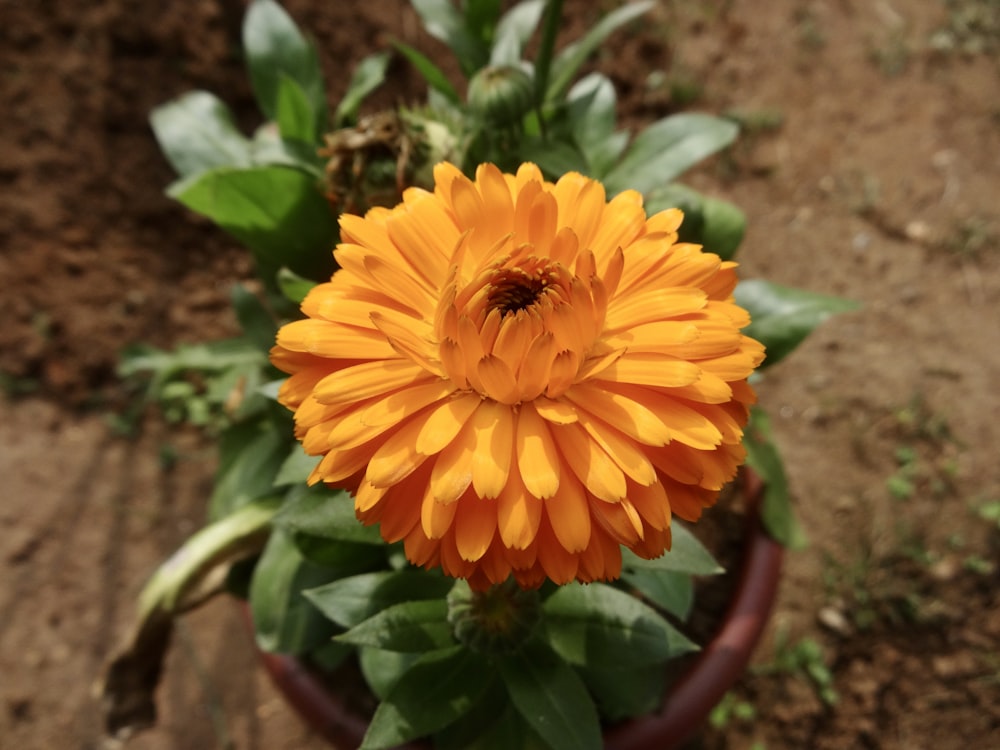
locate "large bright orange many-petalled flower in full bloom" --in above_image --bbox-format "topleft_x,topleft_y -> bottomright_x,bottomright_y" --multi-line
271,163 -> 763,588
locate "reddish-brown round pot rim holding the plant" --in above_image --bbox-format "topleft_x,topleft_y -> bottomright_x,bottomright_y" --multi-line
252,471 -> 784,750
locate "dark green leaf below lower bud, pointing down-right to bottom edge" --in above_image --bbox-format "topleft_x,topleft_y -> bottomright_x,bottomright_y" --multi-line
497,641 -> 603,750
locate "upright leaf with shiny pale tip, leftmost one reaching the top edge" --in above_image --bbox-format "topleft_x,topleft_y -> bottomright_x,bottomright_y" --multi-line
243,0 -> 326,140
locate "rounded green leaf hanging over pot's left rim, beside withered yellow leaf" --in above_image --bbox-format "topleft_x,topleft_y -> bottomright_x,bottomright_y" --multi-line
250,531 -> 334,654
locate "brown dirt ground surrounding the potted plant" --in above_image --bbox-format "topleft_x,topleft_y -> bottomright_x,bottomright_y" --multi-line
0,0 -> 1000,750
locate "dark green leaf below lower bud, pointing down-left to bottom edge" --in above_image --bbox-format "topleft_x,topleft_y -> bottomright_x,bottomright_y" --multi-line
360,646 -> 492,750
